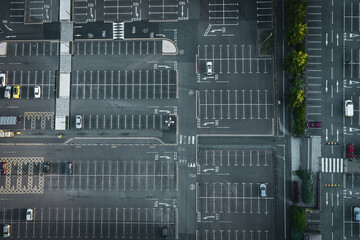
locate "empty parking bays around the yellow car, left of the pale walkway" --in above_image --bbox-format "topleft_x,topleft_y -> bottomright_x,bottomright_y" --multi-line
5,71 -> 55,99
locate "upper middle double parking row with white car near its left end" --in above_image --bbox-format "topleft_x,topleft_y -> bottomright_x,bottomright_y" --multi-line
198,45 -> 272,74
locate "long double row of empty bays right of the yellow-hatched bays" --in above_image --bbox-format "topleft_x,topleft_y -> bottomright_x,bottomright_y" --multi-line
44,159 -> 176,191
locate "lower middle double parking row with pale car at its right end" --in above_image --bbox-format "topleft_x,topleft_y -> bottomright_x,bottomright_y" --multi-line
197,182 -> 273,215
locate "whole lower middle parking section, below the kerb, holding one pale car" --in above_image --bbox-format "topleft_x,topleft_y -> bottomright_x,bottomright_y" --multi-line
197,149 -> 274,239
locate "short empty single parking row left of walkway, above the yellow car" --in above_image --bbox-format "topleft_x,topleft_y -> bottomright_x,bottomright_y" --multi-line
6,41 -> 60,57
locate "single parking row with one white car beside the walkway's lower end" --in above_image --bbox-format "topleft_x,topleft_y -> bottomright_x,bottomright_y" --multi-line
70,114 -> 174,130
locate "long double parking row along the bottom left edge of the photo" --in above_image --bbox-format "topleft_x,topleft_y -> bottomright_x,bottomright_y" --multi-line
0,206 -> 175,239
